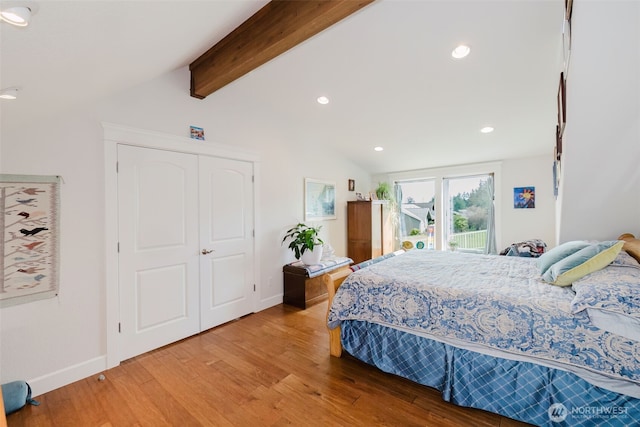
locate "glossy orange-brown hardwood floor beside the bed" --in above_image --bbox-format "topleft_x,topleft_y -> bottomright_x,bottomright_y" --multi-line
8,303 -> 526,427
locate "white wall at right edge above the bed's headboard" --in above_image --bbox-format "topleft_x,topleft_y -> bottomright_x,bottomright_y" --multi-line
558,1 -> 640,242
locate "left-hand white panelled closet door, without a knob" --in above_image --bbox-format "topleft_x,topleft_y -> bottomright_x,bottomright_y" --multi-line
118,145 -> 201,360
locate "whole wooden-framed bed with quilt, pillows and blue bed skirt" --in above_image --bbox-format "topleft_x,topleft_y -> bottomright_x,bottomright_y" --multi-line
324,241 -> 640,426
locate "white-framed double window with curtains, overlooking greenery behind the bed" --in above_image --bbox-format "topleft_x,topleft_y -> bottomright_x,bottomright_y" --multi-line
390,162 -> 501,254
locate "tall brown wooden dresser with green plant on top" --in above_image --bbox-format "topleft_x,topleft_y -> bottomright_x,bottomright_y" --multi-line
347,200 -> 393,264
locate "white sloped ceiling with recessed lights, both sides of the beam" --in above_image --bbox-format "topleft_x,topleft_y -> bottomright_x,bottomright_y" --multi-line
0,0 -> 564,173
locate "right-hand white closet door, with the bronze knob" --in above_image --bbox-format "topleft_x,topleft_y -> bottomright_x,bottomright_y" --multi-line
200,156 -> 255,330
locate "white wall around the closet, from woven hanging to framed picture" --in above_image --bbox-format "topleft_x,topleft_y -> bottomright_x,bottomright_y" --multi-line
0,68 -> 370,395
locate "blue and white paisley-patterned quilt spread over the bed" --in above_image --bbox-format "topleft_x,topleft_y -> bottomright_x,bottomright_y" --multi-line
328,250 -> 640,385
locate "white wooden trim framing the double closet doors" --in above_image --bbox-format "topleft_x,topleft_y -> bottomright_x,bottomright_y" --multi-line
102,122 -> 266,369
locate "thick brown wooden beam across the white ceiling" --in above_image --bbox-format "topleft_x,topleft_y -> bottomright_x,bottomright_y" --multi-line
189,0 -> 374,99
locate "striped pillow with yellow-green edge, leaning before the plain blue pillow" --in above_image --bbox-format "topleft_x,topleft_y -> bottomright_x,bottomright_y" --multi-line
542,240 -> 624,286
